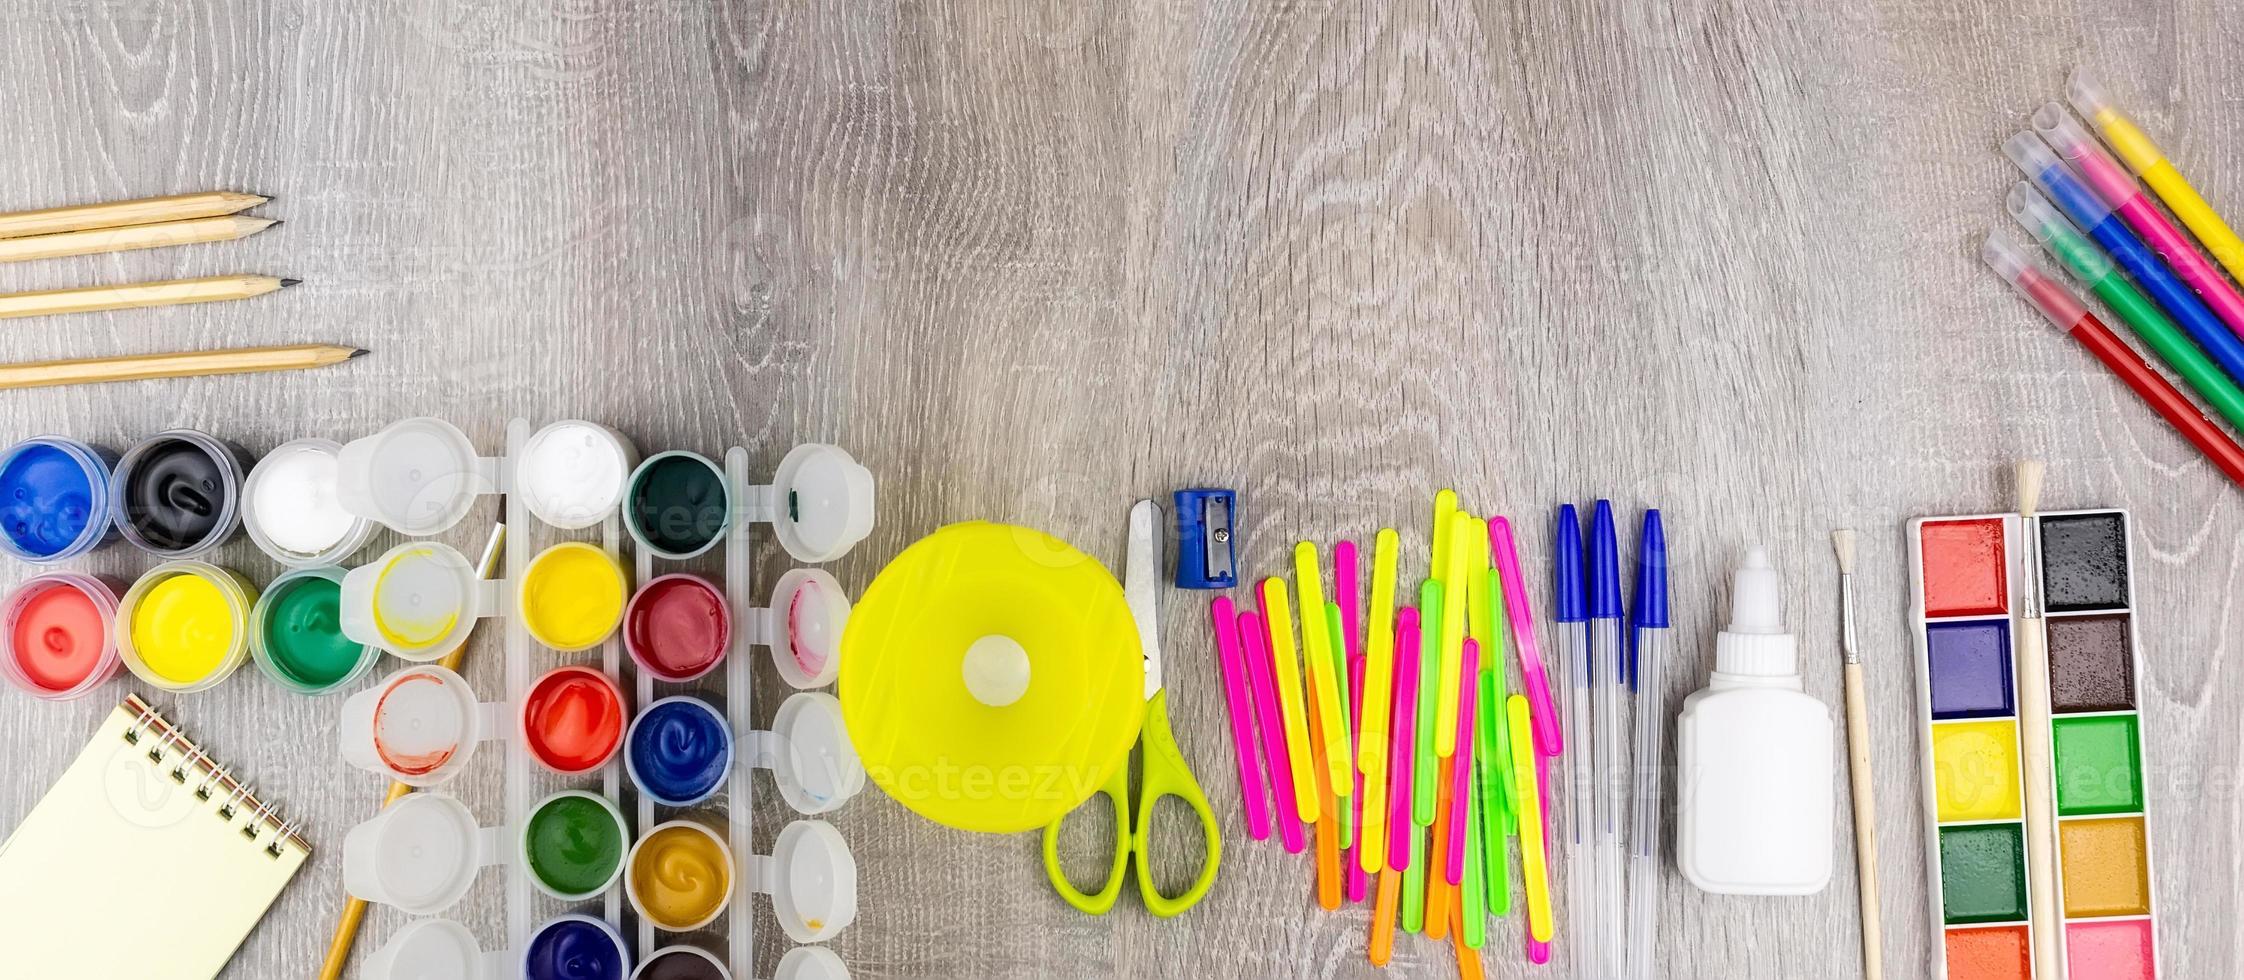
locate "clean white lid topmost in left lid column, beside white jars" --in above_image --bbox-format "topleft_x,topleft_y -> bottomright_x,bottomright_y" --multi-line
337,417 -> 498,536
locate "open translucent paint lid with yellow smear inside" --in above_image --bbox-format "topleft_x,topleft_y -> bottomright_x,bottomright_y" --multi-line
341,540 -> 500,662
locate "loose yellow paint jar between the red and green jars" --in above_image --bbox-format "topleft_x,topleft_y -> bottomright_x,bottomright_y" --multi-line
114,561 -> 258,693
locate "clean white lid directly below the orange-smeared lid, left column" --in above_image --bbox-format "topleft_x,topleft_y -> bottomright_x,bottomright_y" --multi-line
343,792 -> 507,915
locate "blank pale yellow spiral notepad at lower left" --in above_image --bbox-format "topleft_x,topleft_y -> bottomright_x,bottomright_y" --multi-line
0,695 -> 312,980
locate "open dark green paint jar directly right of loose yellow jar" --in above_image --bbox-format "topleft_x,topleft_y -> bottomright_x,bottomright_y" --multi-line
249,567 -> 381,695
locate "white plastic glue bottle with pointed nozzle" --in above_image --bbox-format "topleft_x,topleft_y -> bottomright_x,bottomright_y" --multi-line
1676,547 -> 1836,895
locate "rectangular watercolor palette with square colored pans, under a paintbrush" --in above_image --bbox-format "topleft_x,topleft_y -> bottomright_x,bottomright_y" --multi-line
1910,509 -> 2159,980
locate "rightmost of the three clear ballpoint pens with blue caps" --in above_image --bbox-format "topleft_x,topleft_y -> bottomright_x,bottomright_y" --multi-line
1627,509 -> 1670,980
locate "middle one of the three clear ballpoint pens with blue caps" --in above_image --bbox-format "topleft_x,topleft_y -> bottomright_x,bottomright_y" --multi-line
1589,500 -> 1627,976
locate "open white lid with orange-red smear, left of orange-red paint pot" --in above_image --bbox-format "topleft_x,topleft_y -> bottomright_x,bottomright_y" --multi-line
339,664 -> 505,787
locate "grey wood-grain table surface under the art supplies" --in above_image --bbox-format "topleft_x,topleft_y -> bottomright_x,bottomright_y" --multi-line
0,0 -> 2244,978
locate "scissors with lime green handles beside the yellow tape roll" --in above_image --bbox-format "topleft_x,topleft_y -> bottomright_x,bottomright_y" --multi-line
1043,500 -> 1223,919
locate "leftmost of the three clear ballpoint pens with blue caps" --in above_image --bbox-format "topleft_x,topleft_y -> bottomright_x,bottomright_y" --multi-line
1551,505 -> 1604,976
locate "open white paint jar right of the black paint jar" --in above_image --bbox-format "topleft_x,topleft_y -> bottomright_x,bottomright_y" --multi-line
242,440 -> 375,567
